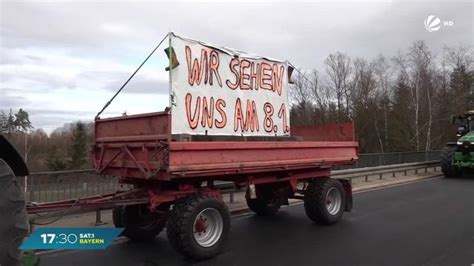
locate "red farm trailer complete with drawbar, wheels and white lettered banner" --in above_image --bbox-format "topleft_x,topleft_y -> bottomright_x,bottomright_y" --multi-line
25,33 -> 358,259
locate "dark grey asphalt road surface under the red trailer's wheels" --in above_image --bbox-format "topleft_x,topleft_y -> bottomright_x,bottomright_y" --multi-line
40,178 -> 474,266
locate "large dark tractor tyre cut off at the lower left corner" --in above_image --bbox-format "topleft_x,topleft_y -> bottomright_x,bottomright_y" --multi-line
0,159 -> 29,265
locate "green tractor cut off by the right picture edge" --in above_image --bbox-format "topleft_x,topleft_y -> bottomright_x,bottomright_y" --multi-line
441,110 -> 474,178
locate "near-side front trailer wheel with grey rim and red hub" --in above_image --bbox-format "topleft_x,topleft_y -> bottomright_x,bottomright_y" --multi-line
166,195 -> 230,260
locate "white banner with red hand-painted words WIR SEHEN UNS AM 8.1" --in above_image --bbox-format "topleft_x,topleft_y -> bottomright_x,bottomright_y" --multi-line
171,34 -> 290,136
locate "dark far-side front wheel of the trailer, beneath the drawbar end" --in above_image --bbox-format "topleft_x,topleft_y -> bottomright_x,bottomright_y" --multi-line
121,205 -> 166,241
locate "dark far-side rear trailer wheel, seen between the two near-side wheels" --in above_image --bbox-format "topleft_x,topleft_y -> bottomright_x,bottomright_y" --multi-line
245,187 -> 283,216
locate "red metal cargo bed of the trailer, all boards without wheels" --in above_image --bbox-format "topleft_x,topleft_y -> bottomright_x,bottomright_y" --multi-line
92,112 -> 358,179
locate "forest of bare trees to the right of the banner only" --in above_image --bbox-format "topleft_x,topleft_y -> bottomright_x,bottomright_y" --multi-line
290,41 -> 474,153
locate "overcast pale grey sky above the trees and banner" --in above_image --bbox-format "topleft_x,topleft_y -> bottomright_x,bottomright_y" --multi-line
0,0 -> 474,132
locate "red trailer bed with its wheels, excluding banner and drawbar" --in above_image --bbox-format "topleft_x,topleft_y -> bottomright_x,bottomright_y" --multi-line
93,112 -> 357,259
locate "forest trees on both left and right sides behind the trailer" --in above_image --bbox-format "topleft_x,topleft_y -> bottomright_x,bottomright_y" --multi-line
0,41 -> 474,172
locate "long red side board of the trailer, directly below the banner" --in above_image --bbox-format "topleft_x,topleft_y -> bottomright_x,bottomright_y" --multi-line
168,141 -> 357,175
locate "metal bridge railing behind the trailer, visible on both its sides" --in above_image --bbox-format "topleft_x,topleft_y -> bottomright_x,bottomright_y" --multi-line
18,151 -> 440,202
